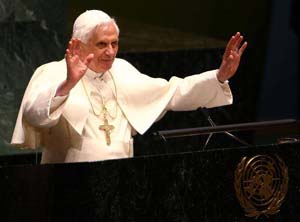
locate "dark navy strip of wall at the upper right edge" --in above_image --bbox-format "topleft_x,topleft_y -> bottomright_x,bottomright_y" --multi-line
258,0 -> 300,120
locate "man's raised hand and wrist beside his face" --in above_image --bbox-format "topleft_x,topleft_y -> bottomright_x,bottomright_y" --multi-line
55,39 -> 94,96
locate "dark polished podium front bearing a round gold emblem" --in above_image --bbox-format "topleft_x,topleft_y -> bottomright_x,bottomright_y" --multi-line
0,120 -> 300,222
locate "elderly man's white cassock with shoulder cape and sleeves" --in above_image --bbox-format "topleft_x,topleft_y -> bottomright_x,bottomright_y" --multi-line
11,58 -> 232,163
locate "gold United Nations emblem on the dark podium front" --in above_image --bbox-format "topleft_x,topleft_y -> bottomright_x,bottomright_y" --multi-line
234,155 -> 288,219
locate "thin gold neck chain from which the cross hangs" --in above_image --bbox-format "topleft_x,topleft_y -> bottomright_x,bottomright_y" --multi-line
81,71 -> 118,119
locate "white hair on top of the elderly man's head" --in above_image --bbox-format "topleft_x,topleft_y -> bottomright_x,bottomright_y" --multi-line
72,10 -> 120,43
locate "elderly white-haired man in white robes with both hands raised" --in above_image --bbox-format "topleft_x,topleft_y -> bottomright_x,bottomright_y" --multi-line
12,10 -> 247,163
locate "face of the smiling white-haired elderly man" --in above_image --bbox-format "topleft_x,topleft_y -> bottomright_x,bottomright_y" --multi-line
80,22 -> 119,72
